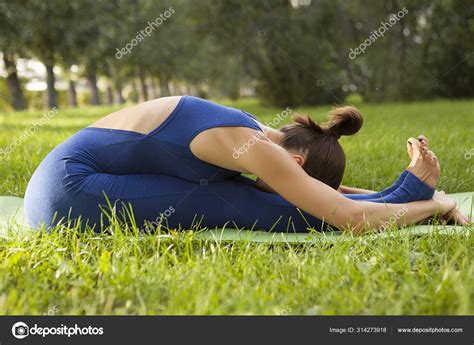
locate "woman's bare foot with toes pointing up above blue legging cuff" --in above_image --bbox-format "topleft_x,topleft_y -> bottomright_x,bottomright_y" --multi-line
407,138 -> 441,188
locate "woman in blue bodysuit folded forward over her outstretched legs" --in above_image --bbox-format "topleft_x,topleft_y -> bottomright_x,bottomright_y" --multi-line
25,96 -> 462,232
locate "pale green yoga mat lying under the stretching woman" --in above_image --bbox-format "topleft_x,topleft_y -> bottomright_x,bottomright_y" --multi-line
0,192 -> 474,243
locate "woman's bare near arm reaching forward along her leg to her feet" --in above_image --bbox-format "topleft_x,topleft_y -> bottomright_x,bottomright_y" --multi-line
238,140 -> 456,232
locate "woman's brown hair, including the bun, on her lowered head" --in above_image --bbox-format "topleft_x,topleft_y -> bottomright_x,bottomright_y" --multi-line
280,106 -> 363,189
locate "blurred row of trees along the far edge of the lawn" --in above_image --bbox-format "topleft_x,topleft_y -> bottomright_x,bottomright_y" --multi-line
0,0 -> 474,109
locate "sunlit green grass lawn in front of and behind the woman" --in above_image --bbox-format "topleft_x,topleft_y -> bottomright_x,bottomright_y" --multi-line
0,100 -> 474,315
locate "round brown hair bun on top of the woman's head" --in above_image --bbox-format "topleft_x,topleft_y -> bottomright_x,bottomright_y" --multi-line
323,105 -> 364,138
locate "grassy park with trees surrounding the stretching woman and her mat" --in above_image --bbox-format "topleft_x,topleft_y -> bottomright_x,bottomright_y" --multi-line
0,0 -> 474,315
